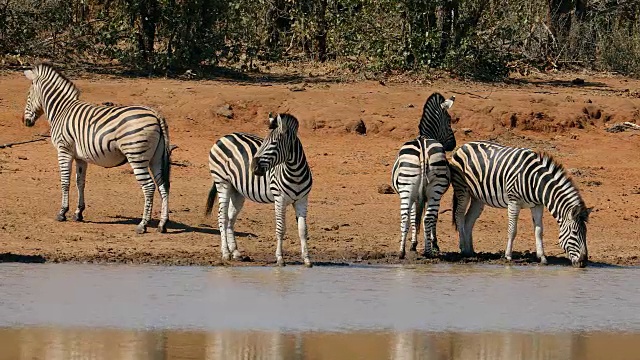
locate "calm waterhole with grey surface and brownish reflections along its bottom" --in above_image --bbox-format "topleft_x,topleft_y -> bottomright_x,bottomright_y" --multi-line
0,264 -> 640,360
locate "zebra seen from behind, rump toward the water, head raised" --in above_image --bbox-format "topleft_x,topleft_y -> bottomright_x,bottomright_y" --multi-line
391,92 -> 456,259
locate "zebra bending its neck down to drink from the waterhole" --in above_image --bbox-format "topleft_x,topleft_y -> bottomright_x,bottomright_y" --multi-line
450,141 -> 591,267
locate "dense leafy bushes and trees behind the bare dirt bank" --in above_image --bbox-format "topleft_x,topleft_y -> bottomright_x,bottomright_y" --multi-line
0,0 -> 640,80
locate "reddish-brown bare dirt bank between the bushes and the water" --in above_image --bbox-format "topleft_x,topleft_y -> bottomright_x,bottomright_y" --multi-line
0,72 -> 640,265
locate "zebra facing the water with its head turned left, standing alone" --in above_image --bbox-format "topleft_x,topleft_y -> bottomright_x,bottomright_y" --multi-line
206,114 -> 312,267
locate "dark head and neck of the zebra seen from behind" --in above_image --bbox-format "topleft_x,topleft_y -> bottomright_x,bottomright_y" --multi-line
418,92 -> 456,151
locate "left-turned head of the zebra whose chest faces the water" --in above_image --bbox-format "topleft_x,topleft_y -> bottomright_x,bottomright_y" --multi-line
251,113 -> 298,176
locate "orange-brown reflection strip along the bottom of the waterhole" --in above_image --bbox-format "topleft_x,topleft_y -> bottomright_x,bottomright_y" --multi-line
0,328 -> 640,360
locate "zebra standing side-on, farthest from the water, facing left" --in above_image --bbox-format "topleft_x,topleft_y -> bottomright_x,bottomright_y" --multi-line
23,64 -> 170,234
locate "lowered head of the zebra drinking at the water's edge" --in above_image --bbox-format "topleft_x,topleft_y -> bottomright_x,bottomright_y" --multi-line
559,204 -> 591,267
